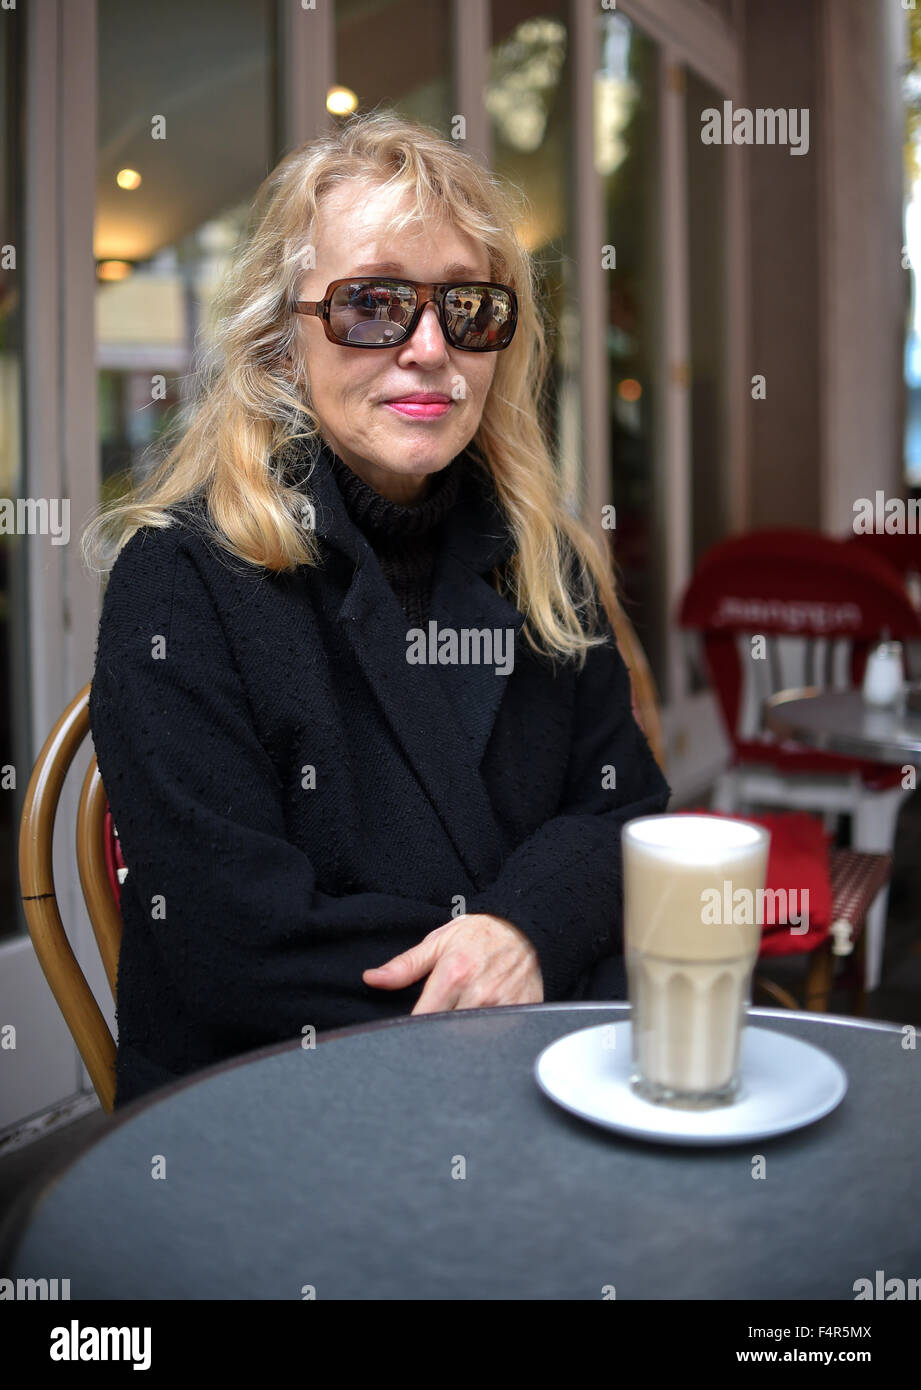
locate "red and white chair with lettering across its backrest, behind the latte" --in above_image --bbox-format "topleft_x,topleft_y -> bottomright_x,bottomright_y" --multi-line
678,530 -> 921,990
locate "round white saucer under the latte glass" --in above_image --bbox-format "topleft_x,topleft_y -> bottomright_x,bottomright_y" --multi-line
533,1022 -> 847,1144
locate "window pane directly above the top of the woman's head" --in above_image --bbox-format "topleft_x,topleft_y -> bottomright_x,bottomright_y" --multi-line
335,0 -> 453,135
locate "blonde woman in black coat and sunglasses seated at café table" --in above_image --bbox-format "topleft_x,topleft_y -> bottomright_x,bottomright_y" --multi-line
85,113 -> 668,1105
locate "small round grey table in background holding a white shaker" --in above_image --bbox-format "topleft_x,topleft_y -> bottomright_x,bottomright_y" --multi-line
764,688 -> 921,766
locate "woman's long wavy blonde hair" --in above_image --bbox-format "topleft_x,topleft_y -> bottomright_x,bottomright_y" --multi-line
82,110 -> 620,666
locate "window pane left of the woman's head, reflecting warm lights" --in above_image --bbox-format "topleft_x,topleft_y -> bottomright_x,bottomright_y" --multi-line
94,0 -> 275,502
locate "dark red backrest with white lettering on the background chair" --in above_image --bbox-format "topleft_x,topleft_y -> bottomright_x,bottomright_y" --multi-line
678,530 -> 921,742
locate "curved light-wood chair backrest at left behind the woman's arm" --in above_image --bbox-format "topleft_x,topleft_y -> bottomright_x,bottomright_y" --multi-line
19,681 -> 121,1113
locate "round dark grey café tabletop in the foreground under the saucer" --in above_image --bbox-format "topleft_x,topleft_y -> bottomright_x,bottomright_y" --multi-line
3,1002 -> 921,1301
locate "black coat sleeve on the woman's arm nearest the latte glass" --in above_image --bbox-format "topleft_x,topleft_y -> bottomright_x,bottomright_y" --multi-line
467,624 -> 671,999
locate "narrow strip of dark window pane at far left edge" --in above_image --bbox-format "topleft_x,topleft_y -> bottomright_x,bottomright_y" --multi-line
0,10 -> 27,937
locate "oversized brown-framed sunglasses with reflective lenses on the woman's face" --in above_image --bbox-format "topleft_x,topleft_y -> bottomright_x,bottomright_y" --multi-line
292,275 -> 518,352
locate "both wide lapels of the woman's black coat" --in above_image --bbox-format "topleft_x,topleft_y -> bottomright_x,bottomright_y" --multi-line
298,449 -> 524,888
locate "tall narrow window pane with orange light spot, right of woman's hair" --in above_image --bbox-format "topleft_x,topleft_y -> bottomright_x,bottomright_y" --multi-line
595,13 -> 667,699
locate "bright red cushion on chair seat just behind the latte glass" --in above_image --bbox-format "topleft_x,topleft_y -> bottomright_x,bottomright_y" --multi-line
677,808 -> 832,956
